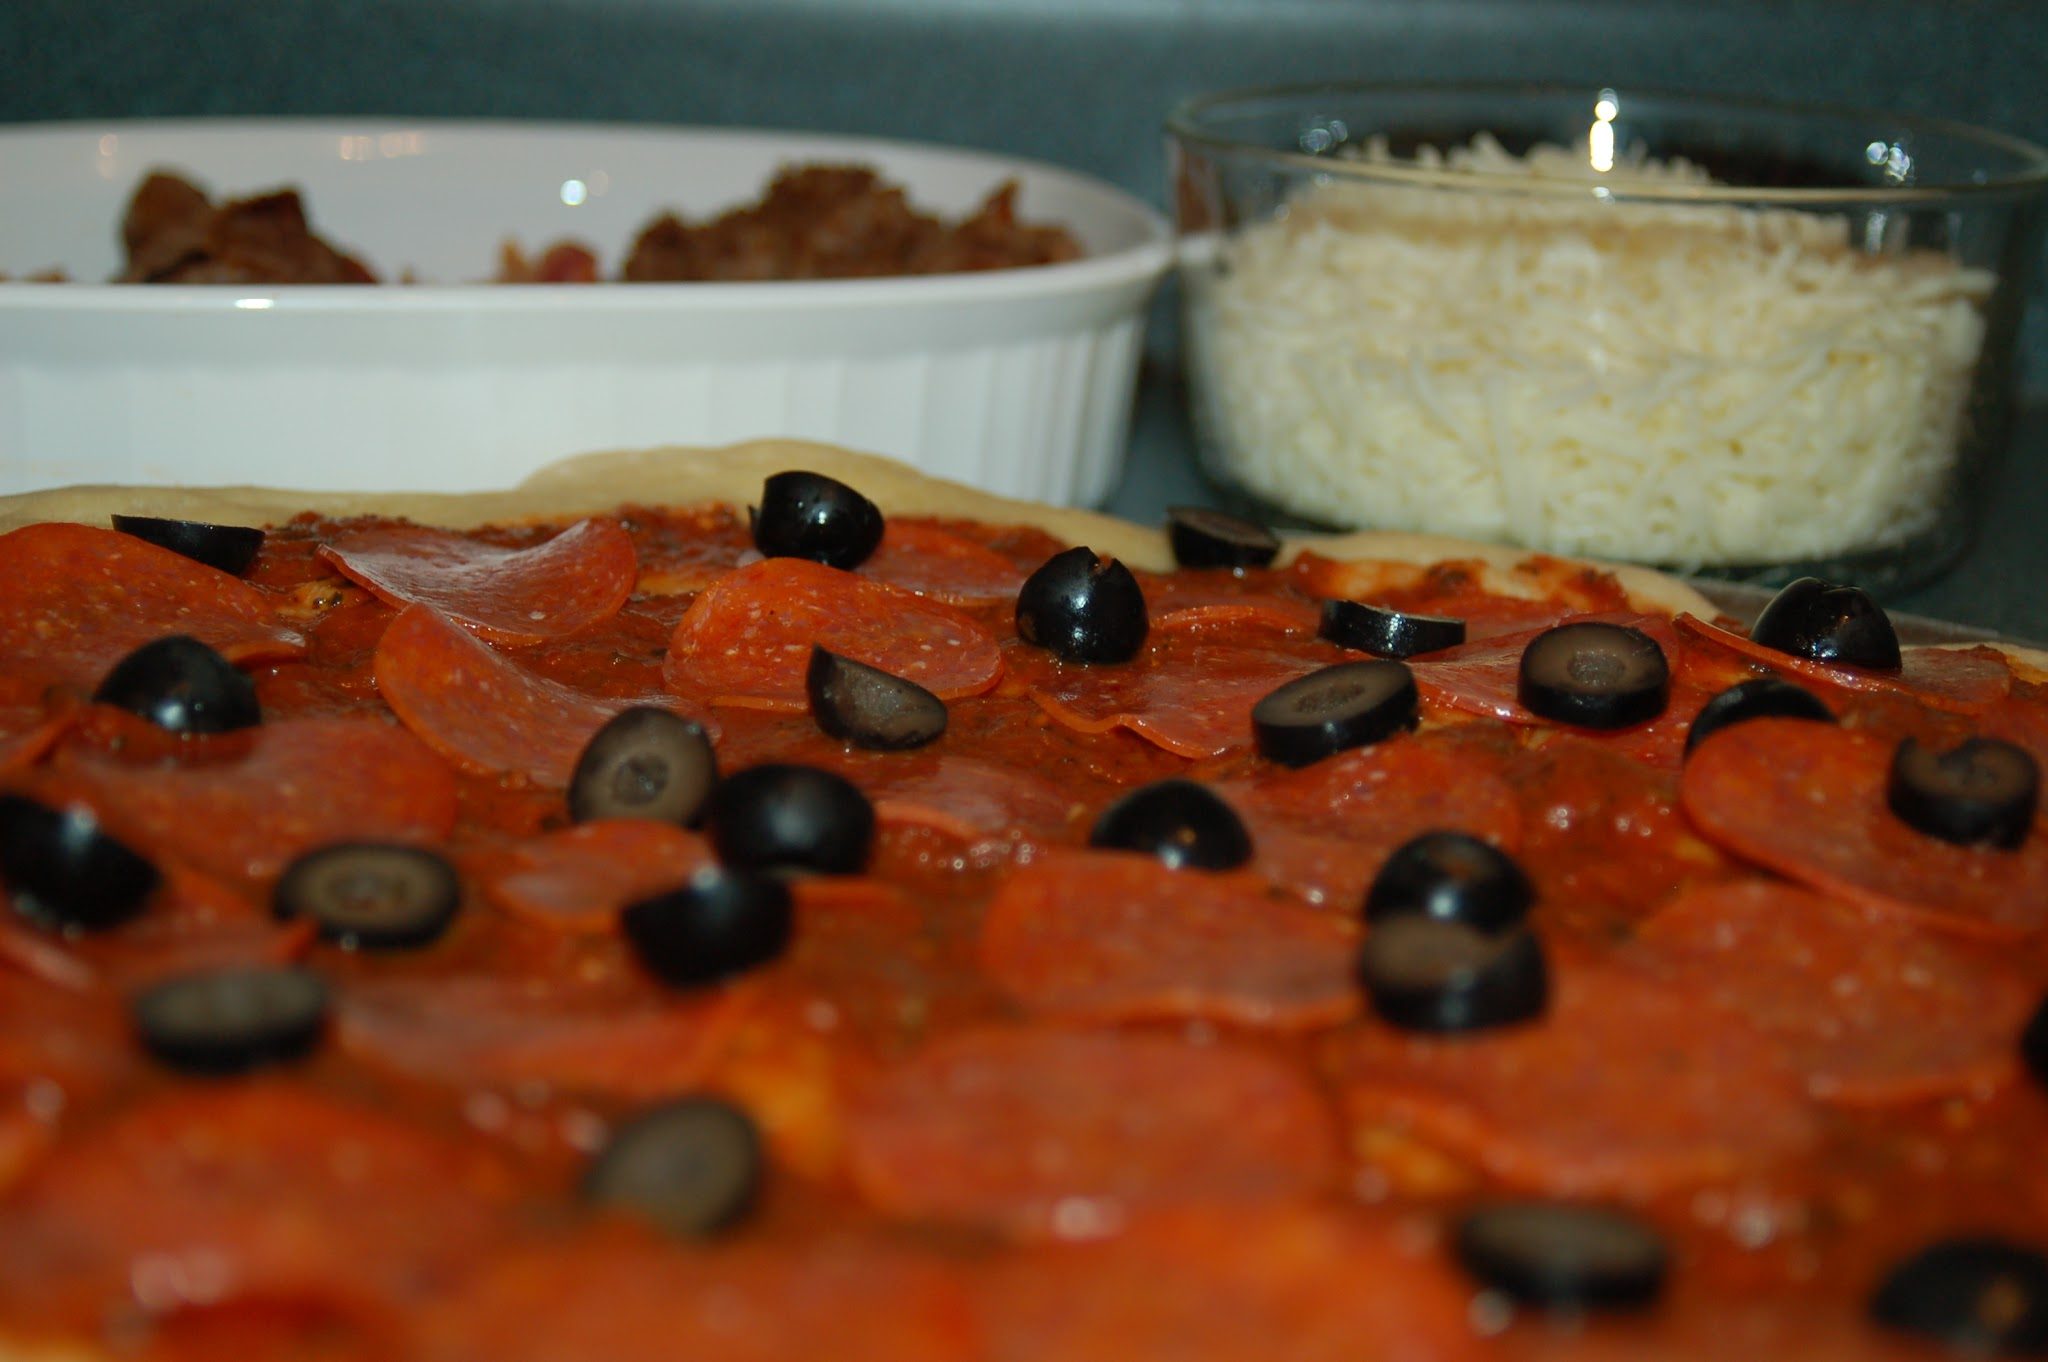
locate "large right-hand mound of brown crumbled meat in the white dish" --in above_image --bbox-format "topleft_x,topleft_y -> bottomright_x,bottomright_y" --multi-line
623,166 -> 1081,283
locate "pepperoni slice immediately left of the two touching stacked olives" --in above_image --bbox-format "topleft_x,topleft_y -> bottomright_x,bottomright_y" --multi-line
981,852 -> 1358,1030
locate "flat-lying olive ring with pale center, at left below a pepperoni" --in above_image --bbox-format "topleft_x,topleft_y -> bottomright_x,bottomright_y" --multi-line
270,842 -> 463,950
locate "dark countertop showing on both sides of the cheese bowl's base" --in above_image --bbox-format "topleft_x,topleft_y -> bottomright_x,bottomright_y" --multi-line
1108,367 -> 2048,641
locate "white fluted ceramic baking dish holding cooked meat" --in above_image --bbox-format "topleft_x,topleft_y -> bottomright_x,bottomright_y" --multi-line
0,121 -> 1171,504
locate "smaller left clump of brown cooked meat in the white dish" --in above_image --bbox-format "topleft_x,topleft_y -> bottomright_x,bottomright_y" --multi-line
117,172 -> 377,285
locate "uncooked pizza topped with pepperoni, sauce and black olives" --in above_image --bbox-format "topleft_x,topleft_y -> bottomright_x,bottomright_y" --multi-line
0,442 -> 2048,1362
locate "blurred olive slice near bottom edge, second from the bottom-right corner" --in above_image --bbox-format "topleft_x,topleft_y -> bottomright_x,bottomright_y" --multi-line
1452,1202 -> 1671,1309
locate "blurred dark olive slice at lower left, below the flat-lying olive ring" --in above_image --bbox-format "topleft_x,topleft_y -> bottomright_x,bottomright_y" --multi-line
131,965 -> 328,1075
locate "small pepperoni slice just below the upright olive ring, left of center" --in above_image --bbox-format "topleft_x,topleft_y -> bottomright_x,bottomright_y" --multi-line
483,819 -> 717,936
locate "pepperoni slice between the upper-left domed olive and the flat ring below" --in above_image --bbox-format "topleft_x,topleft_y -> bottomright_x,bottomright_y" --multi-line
37,719 -> 455,881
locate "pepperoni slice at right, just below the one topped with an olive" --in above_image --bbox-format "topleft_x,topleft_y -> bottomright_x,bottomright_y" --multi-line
1638,883 -> 2036,1106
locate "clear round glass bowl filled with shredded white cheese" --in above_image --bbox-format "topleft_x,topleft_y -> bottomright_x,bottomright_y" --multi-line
1167,86 -> 2048,590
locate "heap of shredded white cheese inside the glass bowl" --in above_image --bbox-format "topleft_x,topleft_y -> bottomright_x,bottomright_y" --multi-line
1190,137 -> 1993,565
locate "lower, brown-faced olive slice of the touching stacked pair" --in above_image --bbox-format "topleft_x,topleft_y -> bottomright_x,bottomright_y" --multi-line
1358,916 -> 1550,1032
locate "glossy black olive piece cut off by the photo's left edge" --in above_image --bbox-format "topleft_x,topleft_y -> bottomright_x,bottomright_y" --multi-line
0,795 -> 160,932
